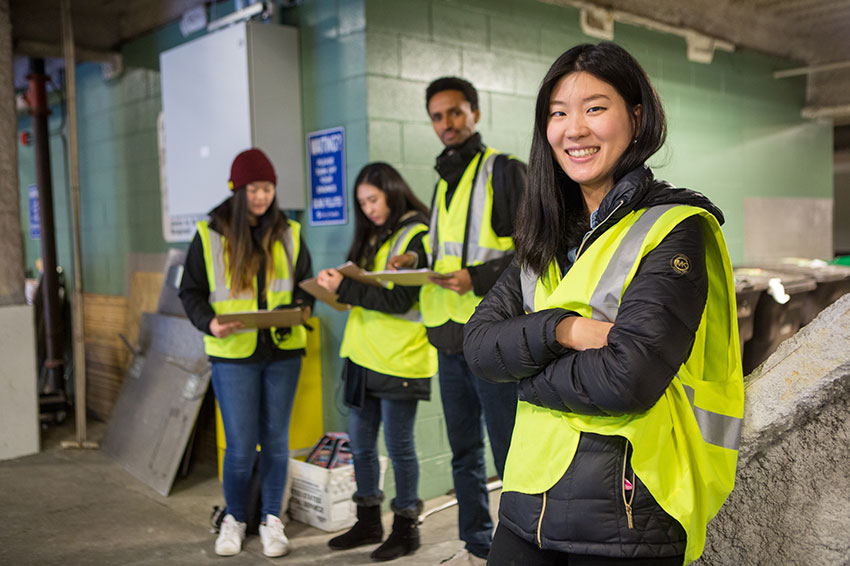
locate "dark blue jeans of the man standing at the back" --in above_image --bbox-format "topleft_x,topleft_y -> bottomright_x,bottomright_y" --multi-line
437,351 -> 517,558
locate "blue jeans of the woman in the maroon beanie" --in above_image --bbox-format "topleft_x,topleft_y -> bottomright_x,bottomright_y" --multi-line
212,357 -> 301,522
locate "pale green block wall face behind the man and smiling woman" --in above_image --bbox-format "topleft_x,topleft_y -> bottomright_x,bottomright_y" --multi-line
366,0 -> 833,263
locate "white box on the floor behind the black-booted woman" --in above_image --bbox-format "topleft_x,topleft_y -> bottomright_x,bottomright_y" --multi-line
289,456 -> 387,532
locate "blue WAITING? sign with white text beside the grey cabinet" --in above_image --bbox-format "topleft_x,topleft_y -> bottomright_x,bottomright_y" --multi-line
307,127 -> 348,226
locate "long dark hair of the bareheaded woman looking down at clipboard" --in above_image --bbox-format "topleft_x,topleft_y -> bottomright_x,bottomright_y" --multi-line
348,161 -> 430,269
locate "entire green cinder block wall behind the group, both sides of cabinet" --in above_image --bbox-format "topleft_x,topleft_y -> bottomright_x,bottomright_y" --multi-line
19,0 -> 833,512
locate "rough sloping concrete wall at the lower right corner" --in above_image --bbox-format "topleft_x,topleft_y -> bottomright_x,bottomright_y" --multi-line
699,295 -> 850,566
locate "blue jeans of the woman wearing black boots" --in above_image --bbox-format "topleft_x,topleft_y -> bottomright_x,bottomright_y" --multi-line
348,393 -> 419,514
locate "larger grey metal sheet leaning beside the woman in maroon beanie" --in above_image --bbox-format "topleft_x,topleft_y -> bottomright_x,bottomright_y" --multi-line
103,313 -> 210,495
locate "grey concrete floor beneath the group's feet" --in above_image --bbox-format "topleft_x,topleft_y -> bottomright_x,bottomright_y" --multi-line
0,418 -> 499,566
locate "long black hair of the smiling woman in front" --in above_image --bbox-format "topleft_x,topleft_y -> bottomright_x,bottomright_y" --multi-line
514,41 -> 667,273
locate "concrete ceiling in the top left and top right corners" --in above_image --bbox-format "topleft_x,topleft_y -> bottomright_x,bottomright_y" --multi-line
10,0 -> 850,123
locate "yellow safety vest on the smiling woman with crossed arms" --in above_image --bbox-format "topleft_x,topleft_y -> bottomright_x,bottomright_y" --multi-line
510,205 -> 744,564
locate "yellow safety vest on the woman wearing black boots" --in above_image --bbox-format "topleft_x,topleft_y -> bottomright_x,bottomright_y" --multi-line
339,223 -> 437,378
